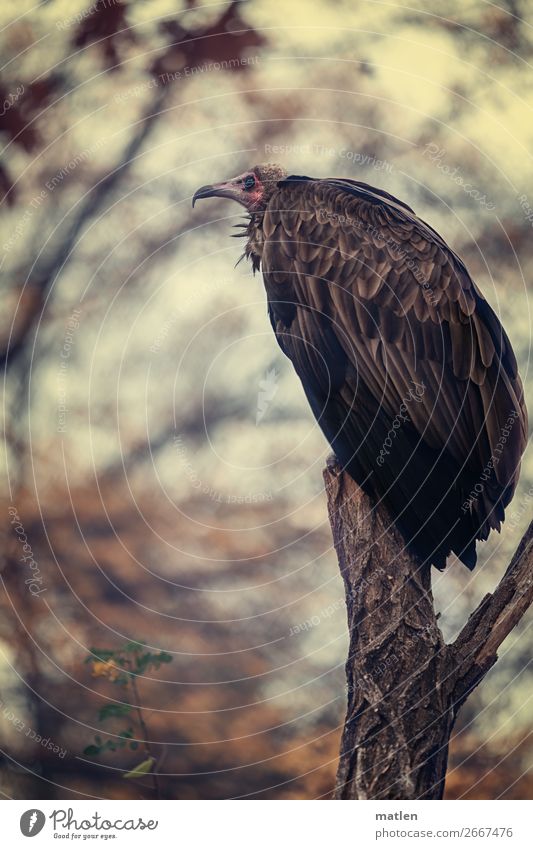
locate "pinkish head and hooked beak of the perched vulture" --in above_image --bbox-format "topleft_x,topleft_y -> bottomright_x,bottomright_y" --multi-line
192,164 -> 287,212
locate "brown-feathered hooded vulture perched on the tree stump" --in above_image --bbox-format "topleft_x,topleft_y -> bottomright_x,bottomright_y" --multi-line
192,164 -> 527,570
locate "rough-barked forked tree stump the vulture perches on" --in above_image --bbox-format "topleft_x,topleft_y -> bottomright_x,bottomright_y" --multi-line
324,466 -> 533,799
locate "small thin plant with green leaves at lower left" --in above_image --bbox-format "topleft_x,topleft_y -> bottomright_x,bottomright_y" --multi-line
83,641 -> 172,798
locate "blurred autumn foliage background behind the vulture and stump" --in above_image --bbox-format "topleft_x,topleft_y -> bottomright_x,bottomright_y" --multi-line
0,0 -> 533,798
